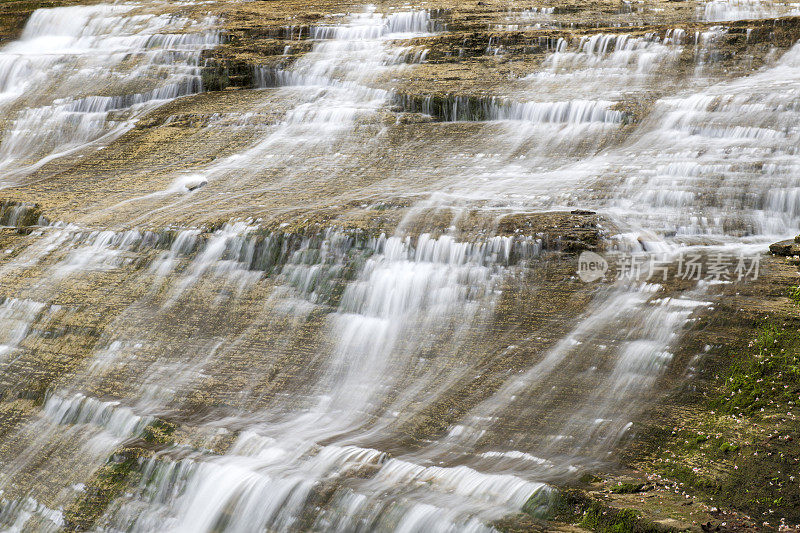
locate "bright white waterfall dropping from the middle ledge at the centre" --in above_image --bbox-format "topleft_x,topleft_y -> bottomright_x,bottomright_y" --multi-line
310,235 -> 513,421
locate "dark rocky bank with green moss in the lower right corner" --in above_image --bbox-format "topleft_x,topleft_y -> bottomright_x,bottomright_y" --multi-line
630,266 -> 800,530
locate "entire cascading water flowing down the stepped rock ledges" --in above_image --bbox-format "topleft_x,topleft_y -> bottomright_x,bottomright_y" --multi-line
0,1 -> 800,532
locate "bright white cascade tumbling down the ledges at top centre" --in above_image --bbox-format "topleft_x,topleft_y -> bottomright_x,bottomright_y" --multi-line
152,6 -> 433,200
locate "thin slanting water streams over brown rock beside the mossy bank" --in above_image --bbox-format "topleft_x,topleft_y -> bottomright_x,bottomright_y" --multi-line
396,282 -> 709,482
